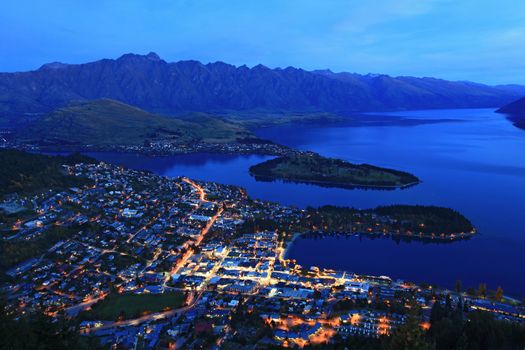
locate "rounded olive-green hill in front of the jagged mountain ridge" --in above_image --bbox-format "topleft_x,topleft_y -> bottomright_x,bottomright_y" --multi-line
19,99 -> 252,146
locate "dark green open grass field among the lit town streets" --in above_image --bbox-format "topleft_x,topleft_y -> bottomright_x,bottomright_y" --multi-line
82,292 -> 185,320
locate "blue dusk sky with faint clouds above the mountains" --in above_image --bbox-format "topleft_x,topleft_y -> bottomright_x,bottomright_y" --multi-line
0,0 -> 525,84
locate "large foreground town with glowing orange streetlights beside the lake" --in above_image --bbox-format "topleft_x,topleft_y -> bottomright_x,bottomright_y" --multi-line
0,162 -> 525,349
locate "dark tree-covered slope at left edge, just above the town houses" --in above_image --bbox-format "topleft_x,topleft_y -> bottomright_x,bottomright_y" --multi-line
0,150 -> 93,197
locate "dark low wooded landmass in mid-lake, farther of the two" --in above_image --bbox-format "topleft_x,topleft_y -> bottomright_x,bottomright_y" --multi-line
250,152 -> 420,189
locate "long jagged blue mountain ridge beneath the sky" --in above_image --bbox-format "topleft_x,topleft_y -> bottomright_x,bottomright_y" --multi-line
0,53 -> 524,116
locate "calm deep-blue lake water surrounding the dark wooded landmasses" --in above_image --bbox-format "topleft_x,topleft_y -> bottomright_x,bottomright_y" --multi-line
82,109 -> 525,297
